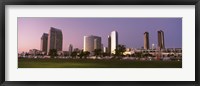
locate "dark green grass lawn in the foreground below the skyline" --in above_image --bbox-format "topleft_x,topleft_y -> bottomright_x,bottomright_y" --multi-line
18,58 -> 182,68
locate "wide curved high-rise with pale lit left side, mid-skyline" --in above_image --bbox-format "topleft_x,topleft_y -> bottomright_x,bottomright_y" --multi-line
83,35 -> 101,53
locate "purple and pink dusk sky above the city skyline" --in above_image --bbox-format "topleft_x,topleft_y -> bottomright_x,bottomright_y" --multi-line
18,17 -> 182,52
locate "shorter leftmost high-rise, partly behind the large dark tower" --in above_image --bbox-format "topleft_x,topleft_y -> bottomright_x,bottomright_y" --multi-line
40,33 -> 48,53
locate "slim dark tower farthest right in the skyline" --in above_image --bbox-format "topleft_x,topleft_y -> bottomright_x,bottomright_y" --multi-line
158,30 -> 165,49
